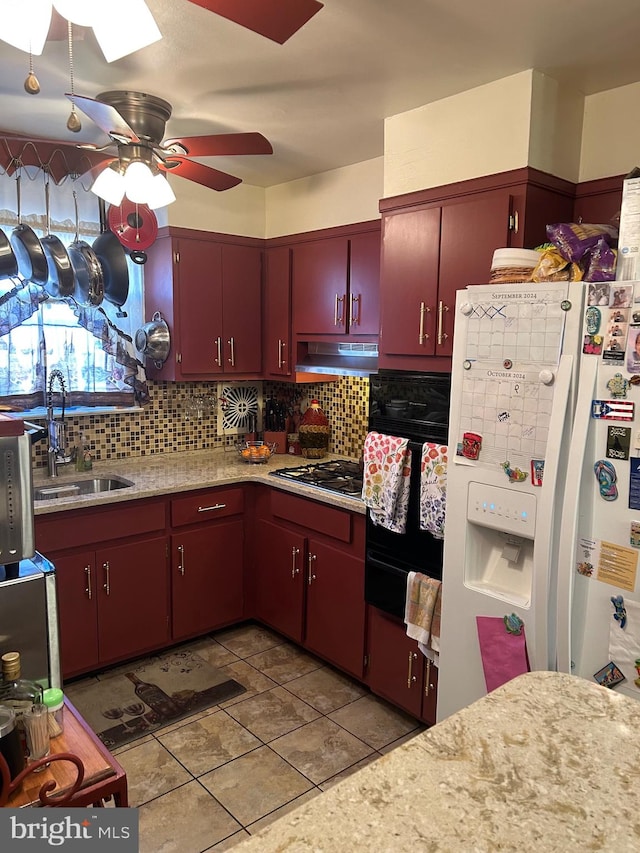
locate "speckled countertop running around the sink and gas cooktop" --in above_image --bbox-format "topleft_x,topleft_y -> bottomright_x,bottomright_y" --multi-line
33,448 -> 365,515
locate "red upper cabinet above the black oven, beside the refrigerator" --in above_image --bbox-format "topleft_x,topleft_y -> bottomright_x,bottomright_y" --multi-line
378,169 -> 573,370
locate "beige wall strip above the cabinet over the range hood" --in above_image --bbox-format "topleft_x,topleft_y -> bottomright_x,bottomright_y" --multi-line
265,157 -> 383,237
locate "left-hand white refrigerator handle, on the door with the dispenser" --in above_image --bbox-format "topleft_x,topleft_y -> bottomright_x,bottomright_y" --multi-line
531,354 -> 573,669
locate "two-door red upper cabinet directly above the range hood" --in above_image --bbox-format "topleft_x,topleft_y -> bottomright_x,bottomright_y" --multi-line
292,222 -> 380,338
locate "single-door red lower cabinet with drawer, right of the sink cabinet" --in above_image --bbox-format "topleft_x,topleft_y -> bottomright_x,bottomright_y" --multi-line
171,487 -> 244,640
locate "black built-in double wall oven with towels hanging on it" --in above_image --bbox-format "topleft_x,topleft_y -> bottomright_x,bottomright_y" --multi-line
365,370 -> 451,617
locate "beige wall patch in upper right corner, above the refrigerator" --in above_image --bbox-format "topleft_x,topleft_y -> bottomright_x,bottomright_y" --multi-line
579,83 -> 640,181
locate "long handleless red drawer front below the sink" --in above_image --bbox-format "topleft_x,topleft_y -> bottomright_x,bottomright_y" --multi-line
36,501 -> 166,554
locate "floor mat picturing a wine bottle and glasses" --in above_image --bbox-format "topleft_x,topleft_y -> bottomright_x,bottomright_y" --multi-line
67,650 -> 245,749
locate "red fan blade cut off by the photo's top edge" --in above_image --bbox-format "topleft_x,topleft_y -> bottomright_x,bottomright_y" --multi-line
189,0 -> 324,44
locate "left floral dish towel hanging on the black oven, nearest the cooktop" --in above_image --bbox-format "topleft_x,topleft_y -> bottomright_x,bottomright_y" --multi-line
362,432 -> 411,533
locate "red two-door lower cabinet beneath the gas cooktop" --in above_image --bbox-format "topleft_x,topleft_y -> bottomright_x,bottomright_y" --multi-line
249,490 -> 365,679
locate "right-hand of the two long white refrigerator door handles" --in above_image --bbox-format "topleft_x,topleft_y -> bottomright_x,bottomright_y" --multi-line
556,357 -> 598,674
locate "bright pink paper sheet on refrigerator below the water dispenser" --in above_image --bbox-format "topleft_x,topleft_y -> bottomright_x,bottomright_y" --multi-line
476,616 -> 529,693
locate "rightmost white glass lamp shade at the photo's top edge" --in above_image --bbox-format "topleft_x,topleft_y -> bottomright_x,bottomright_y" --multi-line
93,0 -> 162,62
